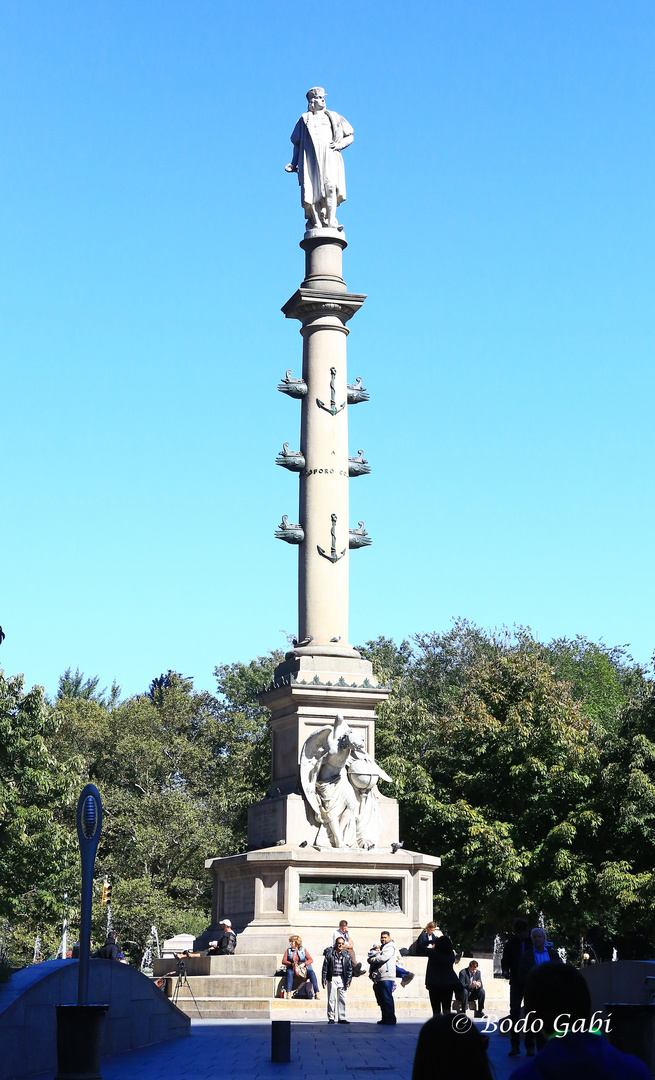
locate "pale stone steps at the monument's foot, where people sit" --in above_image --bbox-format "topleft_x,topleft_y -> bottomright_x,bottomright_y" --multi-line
153,953 -> 509,1022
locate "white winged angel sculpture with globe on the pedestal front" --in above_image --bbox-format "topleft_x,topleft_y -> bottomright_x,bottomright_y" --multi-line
300,714 -> 391,851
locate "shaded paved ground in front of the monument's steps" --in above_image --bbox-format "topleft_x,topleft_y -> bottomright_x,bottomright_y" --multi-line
31,1020 -> 525,1080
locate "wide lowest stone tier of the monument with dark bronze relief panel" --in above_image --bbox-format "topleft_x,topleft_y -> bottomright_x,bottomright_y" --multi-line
201,838 -> 441,960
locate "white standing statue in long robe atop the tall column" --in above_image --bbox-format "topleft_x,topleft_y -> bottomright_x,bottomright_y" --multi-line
285,86 -> 353,229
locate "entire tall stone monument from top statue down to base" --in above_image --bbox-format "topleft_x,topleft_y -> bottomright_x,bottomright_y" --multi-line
206,86 -> 439,956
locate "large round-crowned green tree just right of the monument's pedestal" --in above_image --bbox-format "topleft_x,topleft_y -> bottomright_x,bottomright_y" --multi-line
378,635 -> 601,942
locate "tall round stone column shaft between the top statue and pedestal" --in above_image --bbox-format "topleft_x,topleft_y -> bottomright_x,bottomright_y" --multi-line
282,229 -> 365,658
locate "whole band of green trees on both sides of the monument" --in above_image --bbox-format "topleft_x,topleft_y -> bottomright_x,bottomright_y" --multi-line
0,620 -> 655,962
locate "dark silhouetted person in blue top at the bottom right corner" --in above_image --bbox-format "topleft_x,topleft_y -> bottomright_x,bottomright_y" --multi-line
518,963 -> 651,1080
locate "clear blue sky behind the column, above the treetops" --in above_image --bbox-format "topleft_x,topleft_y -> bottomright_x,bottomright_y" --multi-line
0,0 -> 655,693
